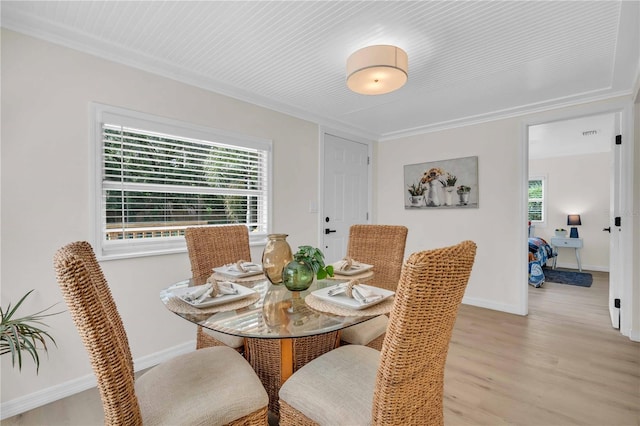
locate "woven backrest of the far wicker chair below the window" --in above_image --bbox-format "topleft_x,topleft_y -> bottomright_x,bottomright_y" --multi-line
184,225 -> 251,284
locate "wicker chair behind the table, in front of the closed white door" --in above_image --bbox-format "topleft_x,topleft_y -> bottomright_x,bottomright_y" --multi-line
340,225 -> 408,350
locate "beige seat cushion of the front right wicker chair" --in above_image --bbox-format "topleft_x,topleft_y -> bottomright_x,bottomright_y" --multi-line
279,345 -> 380,425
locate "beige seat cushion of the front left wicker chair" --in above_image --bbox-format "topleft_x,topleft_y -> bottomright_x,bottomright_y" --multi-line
136,346 -> 269,425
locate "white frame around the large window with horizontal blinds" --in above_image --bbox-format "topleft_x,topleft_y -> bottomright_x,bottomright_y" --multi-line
89,103 -> 273,260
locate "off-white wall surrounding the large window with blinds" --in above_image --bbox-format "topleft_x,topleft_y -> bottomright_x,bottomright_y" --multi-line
0,29 -> 319,403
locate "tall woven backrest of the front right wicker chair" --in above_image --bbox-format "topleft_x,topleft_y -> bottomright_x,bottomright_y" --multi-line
372,241 -> 476,425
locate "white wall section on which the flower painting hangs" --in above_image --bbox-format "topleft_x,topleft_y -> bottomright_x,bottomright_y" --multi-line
375,119 -> 526,312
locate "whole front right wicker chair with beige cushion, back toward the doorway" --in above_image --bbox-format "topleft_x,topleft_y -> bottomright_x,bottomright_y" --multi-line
280,241 -> 476,426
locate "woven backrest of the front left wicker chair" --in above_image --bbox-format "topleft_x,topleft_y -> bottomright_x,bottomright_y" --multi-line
54,241 -> 142,425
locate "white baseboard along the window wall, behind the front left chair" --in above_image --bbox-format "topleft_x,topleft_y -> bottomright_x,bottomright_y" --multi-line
0,340 -> 196,420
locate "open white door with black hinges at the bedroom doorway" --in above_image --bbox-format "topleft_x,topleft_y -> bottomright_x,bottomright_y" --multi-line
609,113 -> 623,329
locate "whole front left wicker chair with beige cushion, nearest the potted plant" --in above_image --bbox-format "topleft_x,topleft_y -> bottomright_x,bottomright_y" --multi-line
54,241 -> 268,426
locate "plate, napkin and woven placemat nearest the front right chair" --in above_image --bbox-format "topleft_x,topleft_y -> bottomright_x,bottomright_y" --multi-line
304,279 -> 395,316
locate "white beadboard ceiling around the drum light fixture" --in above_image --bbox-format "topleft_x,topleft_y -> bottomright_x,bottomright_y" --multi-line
0,0 -> 640,140
